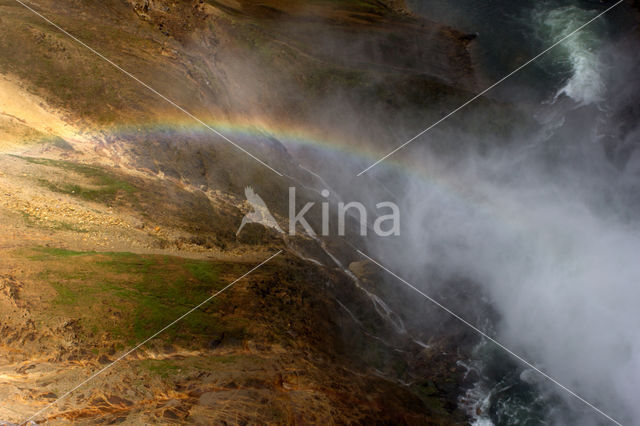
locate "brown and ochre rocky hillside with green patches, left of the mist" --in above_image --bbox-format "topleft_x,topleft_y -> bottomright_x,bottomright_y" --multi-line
0,0 -> 482,424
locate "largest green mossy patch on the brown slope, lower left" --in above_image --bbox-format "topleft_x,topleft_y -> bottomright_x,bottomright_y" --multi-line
25,248 -> 235,344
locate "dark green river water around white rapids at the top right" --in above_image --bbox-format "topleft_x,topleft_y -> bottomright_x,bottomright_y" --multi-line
408,0 -> 634,101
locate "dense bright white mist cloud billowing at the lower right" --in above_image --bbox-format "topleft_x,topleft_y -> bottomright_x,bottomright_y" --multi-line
377,129 -> 640,422
